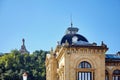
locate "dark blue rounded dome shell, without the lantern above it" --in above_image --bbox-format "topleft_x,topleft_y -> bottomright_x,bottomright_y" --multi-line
61,34 -> 88,45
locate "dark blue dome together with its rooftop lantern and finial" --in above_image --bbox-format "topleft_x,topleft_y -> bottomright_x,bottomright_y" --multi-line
61,23 -> 89,45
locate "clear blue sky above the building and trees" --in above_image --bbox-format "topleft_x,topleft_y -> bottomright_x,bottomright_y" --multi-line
0,0 -> 120,53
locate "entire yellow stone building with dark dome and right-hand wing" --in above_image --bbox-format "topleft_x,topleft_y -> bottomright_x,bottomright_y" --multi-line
45,23 -> 120,80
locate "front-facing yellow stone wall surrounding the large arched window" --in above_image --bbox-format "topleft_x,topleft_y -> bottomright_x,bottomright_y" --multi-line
64,48 -> 105,80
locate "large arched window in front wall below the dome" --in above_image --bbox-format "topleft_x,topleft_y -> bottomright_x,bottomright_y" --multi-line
78,61 -> 93,80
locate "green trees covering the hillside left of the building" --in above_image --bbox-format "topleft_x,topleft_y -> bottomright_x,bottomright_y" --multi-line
0,50 -> 48,80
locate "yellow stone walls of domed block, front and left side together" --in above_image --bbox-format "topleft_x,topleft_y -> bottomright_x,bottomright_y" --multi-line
46,46 -> 107,80
